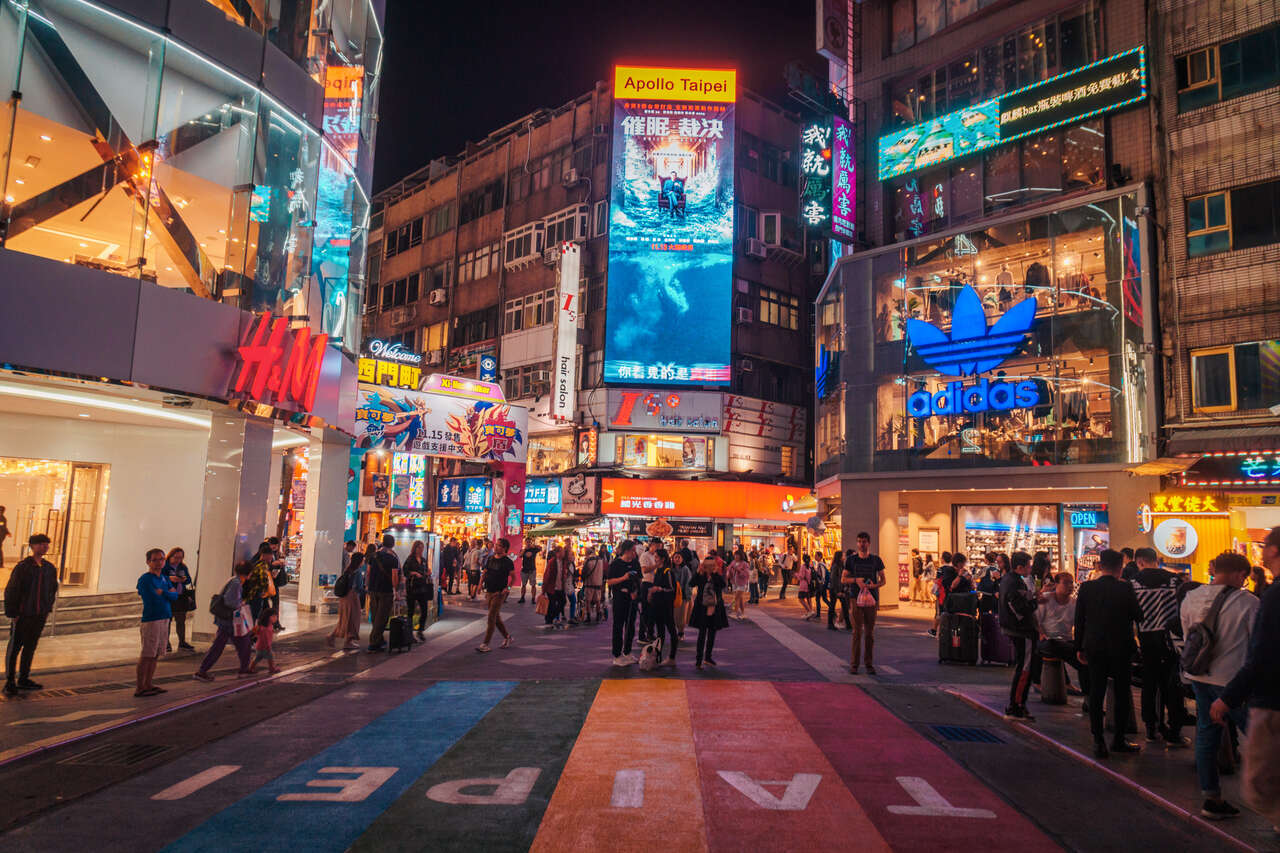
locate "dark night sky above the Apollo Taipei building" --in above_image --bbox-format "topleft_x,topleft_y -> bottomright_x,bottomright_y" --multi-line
374,0 -> 824,190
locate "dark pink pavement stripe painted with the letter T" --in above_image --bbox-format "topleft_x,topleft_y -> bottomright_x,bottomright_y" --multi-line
776,684 -> 1061,853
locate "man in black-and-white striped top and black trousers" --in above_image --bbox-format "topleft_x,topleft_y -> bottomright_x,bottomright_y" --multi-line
1129,548 -> 1187,747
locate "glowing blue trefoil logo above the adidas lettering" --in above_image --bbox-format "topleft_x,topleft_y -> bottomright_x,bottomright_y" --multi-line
906,284 -> 1036,377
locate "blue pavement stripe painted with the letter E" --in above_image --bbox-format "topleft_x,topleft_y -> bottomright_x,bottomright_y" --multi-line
163,681 -> 516,853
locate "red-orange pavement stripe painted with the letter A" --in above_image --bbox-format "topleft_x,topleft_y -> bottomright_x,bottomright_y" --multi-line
691,681 -> 890,853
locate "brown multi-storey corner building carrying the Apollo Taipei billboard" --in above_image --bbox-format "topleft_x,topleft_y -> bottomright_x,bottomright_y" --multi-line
365,69 -> 826,548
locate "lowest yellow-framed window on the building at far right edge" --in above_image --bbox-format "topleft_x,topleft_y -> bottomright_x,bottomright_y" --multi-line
1192,341 -> 1280,412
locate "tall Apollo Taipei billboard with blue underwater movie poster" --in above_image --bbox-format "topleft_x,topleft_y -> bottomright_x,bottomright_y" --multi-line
604,65 -> 737,384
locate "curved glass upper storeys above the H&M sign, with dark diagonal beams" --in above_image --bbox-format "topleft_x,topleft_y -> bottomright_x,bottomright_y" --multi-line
0,0 -> 381,352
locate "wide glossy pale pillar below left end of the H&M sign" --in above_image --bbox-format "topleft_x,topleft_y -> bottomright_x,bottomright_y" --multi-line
193,411 -> 273,635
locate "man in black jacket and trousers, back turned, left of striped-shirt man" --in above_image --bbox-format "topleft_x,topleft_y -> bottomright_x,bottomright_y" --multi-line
1075,548 -> 1142,758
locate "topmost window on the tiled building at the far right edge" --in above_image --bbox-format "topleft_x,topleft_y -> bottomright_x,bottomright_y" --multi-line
1174,27 -> 1280,113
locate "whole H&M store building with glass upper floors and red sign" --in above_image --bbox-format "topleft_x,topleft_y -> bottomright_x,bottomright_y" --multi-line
0,0 -> 383,629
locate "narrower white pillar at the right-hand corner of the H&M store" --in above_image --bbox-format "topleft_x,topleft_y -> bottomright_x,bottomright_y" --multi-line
298,429 -> 351,610
